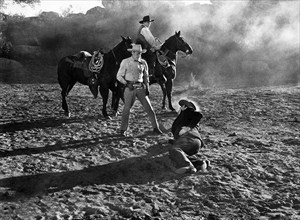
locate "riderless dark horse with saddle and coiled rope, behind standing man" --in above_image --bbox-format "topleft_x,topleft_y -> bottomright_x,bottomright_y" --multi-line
57,36 -> 132,119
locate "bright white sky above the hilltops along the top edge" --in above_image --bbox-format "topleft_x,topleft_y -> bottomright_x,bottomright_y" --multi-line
0,0 -> 211,17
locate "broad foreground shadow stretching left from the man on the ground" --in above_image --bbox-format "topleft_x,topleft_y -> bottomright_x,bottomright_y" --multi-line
0,144 -> 176,201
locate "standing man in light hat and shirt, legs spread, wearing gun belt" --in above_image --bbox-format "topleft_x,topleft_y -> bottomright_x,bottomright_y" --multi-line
117,44 -> 162,136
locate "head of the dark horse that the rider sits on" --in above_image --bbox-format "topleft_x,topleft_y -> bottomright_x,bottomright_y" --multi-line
165,31 -> 193,55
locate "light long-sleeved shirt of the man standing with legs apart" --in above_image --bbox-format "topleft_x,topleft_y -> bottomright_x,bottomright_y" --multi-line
117,57 -> 149,85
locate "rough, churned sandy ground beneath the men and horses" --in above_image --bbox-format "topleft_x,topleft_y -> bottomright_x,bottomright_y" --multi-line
0,84 -> 300,220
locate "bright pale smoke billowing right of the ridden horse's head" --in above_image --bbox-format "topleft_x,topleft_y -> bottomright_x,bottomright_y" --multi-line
163,1 -> 300,87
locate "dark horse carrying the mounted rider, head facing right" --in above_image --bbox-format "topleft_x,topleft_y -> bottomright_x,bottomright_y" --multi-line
149,31 -> 193,111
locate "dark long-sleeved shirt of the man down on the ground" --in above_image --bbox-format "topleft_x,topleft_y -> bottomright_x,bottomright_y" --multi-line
171,108 -> 203,140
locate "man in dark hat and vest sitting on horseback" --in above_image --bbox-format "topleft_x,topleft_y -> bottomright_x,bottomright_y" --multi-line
136,15 -> 161,75
